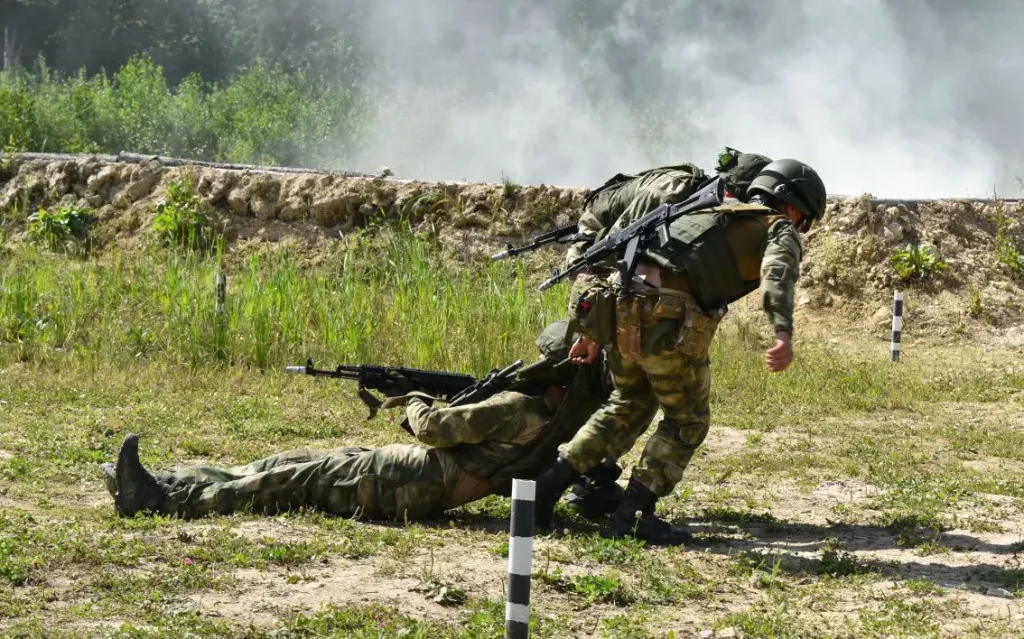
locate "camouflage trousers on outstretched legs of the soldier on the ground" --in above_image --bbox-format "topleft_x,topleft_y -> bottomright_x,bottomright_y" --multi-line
160,444 -> 445,519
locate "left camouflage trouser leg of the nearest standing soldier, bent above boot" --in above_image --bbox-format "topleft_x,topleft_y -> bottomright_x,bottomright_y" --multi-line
561,349 -> 657,472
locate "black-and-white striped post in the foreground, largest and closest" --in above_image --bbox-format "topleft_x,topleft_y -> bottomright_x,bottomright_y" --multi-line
505,479 -> 537,639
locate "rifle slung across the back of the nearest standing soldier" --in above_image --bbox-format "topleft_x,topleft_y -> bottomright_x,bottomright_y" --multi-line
538,178 -> 725,291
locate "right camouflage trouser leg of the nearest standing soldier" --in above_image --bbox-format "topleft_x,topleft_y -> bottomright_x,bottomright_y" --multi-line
633,350 -> 711,497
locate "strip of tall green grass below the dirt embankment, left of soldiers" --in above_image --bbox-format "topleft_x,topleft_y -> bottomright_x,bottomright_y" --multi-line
0,229 -> 561,373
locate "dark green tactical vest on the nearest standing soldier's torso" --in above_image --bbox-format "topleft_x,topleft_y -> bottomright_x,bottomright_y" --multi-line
643,203 -> 778,313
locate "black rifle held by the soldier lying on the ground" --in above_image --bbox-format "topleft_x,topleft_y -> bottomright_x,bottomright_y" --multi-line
285,358 -> 522,435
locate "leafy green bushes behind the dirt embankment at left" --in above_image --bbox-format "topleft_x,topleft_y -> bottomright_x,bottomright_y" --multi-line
0,56 -> 362,165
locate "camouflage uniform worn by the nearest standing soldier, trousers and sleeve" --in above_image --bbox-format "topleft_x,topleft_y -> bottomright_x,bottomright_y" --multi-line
562,201 -> 801,496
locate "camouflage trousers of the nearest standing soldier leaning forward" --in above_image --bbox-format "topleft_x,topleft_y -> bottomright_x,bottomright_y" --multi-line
562,294 -> 718,496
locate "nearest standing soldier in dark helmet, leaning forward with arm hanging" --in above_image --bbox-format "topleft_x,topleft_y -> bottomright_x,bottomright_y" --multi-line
537,160 -> 825,544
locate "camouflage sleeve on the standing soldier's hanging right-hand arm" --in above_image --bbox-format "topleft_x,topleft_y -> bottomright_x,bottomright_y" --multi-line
761,219 -> 803,335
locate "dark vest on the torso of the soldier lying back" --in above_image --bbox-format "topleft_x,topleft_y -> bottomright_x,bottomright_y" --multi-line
444,356 -> 610,487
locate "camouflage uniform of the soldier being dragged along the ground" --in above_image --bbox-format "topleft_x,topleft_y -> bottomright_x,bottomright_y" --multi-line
158,365 -> 607,519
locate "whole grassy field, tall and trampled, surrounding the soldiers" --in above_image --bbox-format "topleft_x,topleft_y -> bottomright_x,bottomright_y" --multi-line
0,227 -> 1024,638
